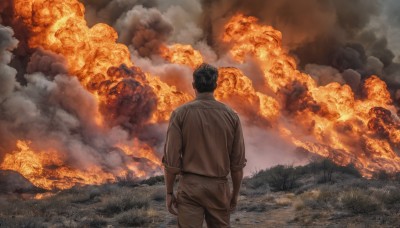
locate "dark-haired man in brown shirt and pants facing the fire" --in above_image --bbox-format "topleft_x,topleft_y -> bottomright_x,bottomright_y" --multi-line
163,64 -> 246,228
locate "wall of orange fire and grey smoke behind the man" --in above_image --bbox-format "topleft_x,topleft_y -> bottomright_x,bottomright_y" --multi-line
0,0 -> 400,189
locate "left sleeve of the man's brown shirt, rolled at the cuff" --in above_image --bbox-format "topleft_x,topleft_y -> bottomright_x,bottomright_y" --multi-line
162,111 -> 182,174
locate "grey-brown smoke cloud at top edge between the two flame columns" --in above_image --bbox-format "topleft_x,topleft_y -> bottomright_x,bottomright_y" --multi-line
83,0 -> 203,57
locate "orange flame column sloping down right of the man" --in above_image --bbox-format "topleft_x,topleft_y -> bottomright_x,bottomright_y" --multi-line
223,15 -> 400,177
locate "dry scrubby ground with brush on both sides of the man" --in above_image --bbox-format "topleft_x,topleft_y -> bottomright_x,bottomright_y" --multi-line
0,161 -> 400,227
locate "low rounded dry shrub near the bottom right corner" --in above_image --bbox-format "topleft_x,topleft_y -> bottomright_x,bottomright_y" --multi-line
341,189 -> 379,214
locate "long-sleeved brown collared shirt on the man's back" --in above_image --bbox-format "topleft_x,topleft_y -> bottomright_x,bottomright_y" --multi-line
163,93 -> 246,177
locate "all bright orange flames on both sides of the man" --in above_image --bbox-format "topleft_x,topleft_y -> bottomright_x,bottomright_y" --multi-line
0,0 -> 400,189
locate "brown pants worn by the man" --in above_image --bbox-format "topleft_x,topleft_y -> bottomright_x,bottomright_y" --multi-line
177,174 -> 230,228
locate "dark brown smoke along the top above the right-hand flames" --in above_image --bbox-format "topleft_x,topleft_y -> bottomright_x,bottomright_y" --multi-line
203,0 -> 380,65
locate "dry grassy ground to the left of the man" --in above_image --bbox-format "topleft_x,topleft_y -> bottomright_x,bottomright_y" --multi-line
0,184 -> 165,227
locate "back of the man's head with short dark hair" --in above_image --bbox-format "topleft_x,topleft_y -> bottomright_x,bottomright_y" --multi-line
193,63 -> 218,93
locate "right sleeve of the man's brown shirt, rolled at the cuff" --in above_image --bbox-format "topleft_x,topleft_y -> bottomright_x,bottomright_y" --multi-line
230,117 -> 247,172
